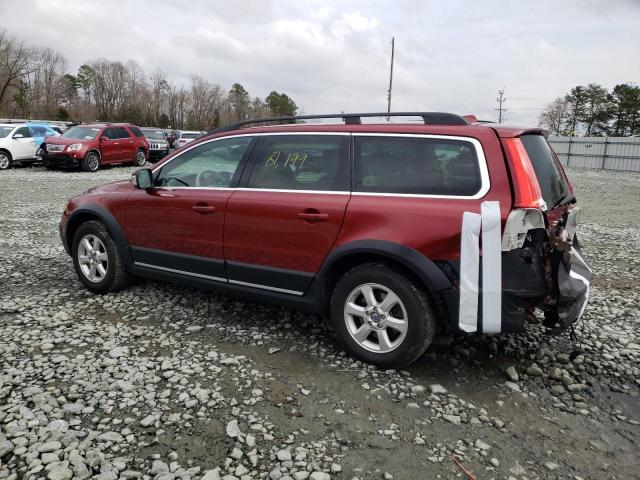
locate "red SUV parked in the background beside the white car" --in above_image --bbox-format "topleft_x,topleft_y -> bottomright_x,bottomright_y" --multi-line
42,123 -> 149,172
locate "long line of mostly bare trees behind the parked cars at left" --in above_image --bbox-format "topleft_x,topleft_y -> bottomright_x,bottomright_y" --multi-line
0,31 -> 298,130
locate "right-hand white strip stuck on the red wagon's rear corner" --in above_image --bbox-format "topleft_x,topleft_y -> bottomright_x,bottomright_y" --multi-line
480,201 -> 502,333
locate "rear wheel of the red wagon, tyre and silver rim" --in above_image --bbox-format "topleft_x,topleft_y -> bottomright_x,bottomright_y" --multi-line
331,263 -> 436,368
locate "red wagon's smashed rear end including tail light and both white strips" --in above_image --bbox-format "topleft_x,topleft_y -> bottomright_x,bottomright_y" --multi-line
438,127 -> 592,335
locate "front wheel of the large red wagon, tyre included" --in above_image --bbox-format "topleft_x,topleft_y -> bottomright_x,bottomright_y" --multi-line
71,220 -> 128,293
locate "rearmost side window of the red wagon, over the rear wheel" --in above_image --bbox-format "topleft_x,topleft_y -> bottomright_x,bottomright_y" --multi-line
354,136 -> 482,196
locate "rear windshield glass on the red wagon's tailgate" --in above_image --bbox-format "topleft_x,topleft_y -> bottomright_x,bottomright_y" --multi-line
520,135 -> 569,208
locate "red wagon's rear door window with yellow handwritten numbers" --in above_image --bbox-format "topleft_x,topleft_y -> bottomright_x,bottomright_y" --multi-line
247,134 -> 351,191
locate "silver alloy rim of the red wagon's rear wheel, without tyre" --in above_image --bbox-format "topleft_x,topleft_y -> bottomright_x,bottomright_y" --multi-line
344,283 -> 409,353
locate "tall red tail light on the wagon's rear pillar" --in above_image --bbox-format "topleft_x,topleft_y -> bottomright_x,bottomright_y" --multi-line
504,138 -> 546,208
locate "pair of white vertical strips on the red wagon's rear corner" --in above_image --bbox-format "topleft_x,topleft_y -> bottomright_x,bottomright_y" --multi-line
458,201 -> 502,333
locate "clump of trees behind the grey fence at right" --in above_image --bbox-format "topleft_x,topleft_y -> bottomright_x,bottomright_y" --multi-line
538,83 -> 640,137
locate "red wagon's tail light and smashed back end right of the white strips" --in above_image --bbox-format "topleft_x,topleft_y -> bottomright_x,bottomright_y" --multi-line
496,129 -> 592,334
